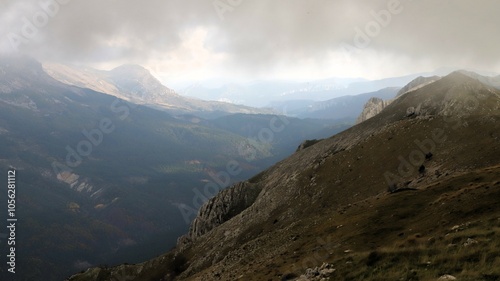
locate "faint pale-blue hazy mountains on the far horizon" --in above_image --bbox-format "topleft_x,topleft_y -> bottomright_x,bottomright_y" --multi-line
180,67 -> 498,108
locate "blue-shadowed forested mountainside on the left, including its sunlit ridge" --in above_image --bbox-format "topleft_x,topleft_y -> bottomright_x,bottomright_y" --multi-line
0,57 -> 350,280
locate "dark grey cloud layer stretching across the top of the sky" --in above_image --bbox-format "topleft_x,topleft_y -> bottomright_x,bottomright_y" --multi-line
0,0 -> 500,77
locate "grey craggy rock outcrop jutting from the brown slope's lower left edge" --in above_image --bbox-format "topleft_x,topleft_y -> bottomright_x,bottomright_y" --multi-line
178,181 -> 261,246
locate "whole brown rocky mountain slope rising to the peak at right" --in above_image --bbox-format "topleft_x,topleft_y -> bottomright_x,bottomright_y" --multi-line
69,72 -> 500,281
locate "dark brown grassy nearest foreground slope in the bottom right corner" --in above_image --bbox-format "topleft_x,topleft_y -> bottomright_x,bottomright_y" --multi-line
274,167 -> 500,281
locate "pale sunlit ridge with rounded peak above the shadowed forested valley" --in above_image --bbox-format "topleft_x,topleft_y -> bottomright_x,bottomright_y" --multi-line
44,63 -> 274,117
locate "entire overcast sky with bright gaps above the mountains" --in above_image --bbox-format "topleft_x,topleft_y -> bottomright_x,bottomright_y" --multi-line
0,0 -> 500,85
